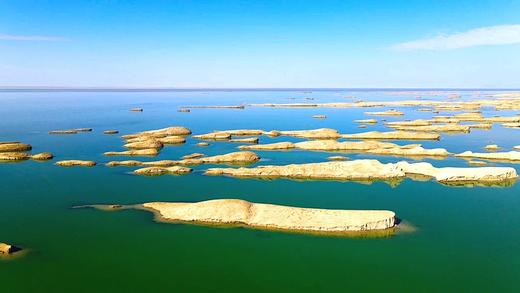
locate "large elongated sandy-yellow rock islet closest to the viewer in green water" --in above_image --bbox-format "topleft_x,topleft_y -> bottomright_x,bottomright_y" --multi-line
133,199 -> 396,235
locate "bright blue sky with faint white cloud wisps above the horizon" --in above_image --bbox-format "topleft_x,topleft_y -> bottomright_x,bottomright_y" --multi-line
0,0 -> 520,88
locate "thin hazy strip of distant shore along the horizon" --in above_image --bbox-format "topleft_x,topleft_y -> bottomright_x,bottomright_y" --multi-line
0,86 -> 520,92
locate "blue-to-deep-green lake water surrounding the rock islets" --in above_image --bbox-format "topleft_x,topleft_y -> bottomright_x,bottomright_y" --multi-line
0,90 -> 520,292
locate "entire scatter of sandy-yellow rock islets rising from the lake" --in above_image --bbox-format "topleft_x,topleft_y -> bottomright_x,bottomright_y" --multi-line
0,93 -> 520,256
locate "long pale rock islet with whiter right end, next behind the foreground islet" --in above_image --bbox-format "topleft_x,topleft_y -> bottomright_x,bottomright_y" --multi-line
205,160 -> 518,185
